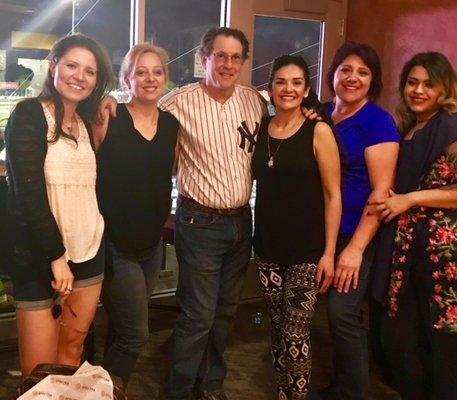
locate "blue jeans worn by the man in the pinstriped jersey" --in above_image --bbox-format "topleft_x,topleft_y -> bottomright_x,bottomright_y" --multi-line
165,203 -> 252,399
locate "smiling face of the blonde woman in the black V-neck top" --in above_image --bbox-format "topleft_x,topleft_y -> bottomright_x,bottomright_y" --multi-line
126,51 -> 166,102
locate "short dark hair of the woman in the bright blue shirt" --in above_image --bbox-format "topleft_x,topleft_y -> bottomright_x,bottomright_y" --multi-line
327,42 -> 382,100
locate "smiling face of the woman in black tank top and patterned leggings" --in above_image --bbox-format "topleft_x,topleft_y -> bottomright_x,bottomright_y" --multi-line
268,64 -> 309,111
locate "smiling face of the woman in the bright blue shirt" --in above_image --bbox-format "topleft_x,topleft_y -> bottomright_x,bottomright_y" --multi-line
333,54 -> 372,105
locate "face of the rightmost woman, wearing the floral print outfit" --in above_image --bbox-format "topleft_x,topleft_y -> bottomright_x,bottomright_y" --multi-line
403,65 -> 443,121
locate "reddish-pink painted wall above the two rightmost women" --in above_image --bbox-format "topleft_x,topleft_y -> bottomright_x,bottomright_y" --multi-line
346,0 -> 457,117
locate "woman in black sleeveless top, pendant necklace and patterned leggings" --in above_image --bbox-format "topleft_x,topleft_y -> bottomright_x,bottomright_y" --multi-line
253,56 -> 341,399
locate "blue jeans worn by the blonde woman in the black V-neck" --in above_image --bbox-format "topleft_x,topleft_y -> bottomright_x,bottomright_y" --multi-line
102,240 -> 163,385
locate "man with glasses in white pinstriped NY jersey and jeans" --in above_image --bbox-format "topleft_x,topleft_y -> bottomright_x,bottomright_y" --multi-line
161,28 -> 266,400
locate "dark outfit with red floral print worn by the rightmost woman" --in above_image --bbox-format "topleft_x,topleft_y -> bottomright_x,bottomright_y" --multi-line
372,110 -> 457,400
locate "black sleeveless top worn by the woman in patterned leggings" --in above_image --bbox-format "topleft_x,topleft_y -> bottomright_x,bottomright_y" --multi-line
252,117 -> 325,264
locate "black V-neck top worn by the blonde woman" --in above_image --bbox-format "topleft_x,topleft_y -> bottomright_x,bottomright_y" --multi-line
97,104 -> 178,256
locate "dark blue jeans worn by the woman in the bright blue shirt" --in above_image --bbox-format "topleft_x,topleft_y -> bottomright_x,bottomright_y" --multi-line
327,236 -> 374,400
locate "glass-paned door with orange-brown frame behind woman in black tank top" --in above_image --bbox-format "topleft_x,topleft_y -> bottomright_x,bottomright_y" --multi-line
228,0 -> 347,101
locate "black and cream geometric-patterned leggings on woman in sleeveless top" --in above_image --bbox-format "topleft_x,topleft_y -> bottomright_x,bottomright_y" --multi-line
256,257 -> 319,400
